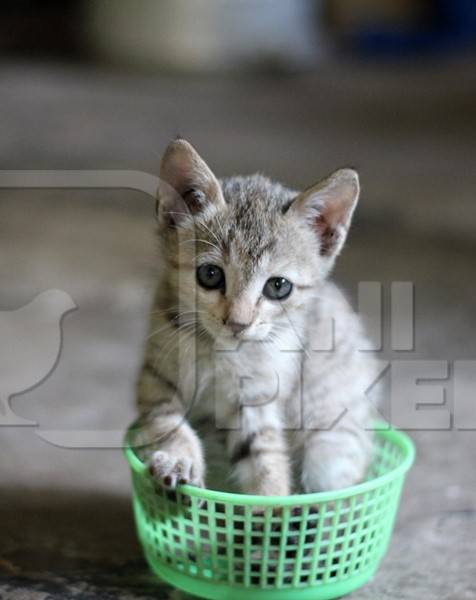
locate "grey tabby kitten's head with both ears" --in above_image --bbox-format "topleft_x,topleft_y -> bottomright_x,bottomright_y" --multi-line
158,139 -> 359,340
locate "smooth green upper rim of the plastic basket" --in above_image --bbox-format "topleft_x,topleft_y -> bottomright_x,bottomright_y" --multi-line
124,421 -> 415,506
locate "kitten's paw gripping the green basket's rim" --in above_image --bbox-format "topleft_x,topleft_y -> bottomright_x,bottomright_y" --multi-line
149,450 -> 205,489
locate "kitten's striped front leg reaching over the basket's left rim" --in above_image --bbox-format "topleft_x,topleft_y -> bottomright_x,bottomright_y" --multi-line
137,359 -> 205,488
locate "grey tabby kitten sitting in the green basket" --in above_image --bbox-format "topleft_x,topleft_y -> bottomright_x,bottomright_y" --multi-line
138,139 -> 375,495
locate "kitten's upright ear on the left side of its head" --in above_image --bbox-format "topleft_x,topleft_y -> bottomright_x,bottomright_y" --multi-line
157,139 -> 225,227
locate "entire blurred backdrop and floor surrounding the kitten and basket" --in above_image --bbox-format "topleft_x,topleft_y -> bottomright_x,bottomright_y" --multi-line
0,0 -> 476,600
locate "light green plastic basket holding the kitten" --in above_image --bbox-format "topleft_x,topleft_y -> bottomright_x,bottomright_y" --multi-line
125,426 -> 415,600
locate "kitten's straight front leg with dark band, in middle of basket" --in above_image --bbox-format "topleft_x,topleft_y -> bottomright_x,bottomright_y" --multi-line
227,406 -> 291,496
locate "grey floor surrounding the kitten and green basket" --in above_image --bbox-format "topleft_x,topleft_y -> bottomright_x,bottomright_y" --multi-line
0,57 -> 476,600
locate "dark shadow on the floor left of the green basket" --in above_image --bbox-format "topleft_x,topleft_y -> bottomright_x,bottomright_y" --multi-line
0,489 -> 184,600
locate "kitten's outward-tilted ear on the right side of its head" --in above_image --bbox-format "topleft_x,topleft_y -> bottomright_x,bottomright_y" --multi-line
291,169 -> 360,262
